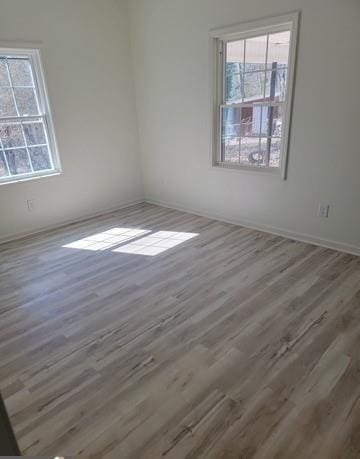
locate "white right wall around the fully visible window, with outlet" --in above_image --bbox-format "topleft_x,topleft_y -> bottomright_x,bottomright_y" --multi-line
129,0 -> 360,253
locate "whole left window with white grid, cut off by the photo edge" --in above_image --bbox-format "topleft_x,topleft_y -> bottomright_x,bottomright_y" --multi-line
0,49 -> 60,183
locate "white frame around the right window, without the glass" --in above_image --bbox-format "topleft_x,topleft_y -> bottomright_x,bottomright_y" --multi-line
210,11 -> 300,180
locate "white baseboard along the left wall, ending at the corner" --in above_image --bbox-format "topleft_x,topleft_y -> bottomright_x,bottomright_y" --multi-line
0,198 -> 145,244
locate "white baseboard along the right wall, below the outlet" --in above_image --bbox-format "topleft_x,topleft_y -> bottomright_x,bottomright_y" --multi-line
145,198 -> 360,256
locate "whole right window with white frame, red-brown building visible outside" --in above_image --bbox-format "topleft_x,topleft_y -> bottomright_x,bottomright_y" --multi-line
211,13 -> 298,178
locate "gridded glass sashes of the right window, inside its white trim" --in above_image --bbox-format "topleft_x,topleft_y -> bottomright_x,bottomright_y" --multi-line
219,29 -> 291,168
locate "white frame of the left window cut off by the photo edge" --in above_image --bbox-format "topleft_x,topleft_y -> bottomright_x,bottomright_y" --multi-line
0,46 -> 62,185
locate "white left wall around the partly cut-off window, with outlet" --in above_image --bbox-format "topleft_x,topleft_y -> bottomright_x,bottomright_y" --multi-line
0,0 -> 143,243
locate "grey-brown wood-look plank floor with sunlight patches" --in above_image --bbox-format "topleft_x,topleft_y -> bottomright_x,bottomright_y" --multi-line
0,204 -> 360,459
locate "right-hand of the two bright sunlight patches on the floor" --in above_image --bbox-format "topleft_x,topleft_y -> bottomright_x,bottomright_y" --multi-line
113,231 -> 199,256
